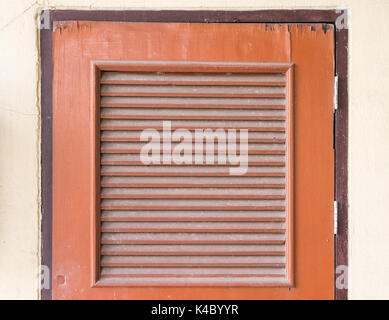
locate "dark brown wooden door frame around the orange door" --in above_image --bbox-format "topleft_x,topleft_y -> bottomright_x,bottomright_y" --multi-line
40,9 -> 348,300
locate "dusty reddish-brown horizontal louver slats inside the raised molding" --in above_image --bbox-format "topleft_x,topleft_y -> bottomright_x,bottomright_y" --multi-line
96,62 -> 291,285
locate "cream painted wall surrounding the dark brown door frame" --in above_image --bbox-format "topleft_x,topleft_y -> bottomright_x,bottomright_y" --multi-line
0,0 -> 389,299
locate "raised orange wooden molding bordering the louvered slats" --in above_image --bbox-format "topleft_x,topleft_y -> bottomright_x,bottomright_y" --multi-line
91,61 -> 294,287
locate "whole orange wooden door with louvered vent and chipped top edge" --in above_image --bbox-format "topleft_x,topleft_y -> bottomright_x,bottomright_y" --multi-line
52,21 -> 334,299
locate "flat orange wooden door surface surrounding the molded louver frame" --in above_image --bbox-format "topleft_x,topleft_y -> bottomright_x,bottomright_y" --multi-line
53,22 -> 333,299
